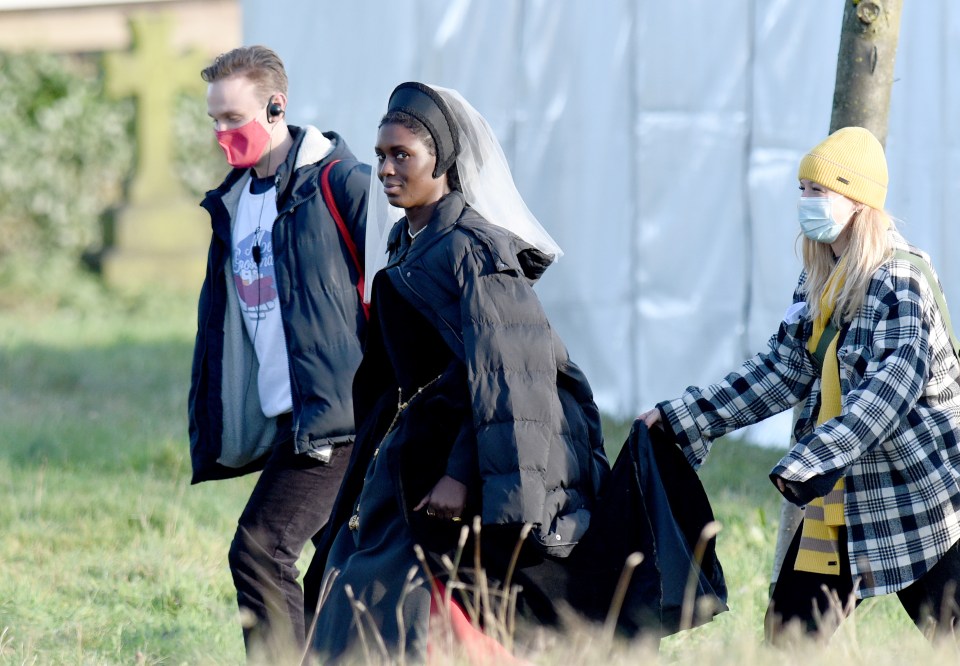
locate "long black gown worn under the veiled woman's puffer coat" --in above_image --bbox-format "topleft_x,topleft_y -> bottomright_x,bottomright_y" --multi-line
314,273 -> 475,662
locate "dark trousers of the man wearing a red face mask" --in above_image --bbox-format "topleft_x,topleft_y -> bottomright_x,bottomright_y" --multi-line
229,426 -> 351,663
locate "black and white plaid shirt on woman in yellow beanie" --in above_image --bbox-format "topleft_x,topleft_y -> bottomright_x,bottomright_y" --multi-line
658,233 -> 960,598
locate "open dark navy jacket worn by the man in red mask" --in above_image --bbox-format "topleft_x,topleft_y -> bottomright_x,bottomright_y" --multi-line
188,126 -> 370,483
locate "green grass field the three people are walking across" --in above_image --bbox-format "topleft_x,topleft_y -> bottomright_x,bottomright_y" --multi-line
0,282 -> 944,666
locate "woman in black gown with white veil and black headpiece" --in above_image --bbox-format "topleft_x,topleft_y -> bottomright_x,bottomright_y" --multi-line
311,83 -> 609,662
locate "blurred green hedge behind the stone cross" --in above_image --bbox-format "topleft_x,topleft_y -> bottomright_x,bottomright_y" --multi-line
0,52 -> 226,285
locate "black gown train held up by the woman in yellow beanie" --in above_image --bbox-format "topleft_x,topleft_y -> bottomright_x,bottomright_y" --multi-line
568,419 -> 727,636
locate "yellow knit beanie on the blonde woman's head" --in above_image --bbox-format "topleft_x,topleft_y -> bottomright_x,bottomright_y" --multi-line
797,127 -> 887,210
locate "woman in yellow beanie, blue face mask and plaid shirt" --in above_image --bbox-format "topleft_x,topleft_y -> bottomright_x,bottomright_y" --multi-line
640,127 -> 960,641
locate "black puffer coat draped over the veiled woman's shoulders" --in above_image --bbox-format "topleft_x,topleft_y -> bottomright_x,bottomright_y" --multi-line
338,192 -> 609,556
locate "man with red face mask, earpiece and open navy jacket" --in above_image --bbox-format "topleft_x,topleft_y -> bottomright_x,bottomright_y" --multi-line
188,46 -> 370,663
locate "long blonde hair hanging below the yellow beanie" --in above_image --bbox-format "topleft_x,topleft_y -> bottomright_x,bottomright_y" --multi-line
802,205 -> 894,327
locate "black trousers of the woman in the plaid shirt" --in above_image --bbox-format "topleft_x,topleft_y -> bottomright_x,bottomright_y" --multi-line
764,522 -> 960,644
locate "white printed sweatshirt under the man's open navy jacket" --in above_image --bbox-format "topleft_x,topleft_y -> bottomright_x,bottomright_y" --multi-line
231,177 -> 293,417
